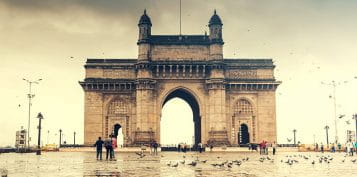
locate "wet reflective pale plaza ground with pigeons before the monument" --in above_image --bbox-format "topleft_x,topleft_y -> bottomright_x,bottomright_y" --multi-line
0,152 -> 357,177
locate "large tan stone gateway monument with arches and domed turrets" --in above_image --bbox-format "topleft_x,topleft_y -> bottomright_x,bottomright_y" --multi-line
79,11 -> 281,146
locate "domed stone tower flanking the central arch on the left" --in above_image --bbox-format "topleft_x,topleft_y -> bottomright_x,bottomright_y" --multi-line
134,10 -> 156,145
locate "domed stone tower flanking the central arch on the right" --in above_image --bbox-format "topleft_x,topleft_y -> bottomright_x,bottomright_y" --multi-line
206,10 -> 229,145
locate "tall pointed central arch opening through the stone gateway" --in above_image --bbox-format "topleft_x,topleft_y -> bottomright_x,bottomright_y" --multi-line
160,89 -> 201,147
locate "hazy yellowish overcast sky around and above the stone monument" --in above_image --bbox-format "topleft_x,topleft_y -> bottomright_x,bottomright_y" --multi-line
0,0 -> 357,146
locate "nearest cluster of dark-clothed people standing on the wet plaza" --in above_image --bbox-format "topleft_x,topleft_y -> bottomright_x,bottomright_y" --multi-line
94,135 -> 117,160
